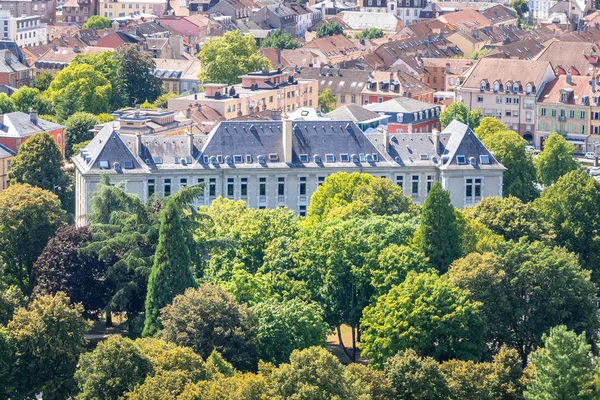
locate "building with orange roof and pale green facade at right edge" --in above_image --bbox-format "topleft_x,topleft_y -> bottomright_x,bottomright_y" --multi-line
536,75 -> 600,153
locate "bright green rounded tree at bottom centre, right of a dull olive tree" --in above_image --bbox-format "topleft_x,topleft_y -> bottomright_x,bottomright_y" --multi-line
252,299 -> 330,364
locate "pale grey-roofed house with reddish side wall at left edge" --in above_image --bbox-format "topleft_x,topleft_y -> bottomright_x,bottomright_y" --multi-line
0,110 -> 65,155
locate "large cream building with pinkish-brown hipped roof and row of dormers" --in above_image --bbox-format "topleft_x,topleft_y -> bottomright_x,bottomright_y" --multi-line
456,58 -> 555,146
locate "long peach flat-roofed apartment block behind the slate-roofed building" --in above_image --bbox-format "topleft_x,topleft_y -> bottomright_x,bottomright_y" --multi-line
169,70 -> 319,119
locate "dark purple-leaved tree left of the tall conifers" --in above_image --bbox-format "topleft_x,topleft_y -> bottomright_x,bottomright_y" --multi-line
33,226 -> 107,315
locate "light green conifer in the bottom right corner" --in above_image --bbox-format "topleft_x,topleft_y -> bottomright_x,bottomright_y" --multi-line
524,325 -> 596,400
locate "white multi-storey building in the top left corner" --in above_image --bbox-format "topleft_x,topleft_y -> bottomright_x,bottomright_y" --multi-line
0,11 -> 48,47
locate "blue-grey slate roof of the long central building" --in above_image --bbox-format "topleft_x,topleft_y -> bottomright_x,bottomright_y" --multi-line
73,120 -> 505,174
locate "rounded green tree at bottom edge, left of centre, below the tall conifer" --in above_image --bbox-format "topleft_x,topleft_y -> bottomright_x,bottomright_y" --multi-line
75,335 -> 152,400
